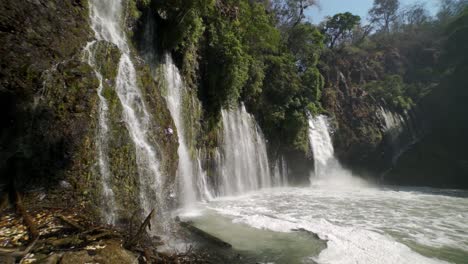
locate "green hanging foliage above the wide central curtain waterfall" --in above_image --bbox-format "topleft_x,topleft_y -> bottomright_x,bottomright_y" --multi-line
153,0 -> 324,151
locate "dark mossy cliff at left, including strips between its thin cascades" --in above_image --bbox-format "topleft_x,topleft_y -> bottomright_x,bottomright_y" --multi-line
0,0 -> 178,223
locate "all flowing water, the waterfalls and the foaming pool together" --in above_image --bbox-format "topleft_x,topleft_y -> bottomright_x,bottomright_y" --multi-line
85,4 -> 468,264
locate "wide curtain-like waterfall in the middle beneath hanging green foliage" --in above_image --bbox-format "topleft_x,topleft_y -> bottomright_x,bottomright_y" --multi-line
218,105 -> 273,195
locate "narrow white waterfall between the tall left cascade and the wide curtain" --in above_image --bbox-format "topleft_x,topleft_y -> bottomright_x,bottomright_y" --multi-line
163,54 -> 212,208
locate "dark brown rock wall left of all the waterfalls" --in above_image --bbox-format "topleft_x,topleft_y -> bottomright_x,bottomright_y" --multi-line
0,0 -> 95,188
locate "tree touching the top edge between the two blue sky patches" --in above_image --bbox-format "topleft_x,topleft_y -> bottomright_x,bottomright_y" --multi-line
369,0 -> 400,33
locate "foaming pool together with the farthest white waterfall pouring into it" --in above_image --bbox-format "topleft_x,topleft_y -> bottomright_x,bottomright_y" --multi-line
183,116 -> 468,264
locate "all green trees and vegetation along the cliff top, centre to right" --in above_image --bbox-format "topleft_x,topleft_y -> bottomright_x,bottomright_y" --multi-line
136,0 -> 463,157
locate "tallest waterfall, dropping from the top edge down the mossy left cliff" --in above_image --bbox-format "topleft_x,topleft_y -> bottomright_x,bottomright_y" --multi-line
90,0 -> 166,227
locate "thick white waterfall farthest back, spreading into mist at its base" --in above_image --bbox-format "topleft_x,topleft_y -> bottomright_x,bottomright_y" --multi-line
309,115 -> 365,188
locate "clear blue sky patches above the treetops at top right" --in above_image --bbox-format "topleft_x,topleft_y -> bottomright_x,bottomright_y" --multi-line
307,0 -> 440,24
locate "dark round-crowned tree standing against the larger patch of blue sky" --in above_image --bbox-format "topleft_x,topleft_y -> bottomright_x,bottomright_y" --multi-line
323,12 -> 361,49
